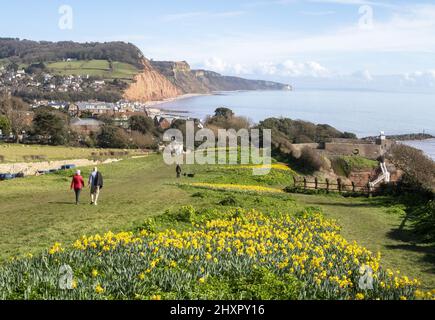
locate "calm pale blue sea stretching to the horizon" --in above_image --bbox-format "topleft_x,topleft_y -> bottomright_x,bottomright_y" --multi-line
159,89 -> 435,160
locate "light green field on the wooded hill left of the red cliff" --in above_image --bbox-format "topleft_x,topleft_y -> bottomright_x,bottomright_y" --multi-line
47,60 -> 139,80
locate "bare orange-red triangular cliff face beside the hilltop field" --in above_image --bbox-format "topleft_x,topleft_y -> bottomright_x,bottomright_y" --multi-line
124,59 -> 183,102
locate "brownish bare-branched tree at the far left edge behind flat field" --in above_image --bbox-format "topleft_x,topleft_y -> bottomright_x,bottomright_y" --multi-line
0,96 -> 29,143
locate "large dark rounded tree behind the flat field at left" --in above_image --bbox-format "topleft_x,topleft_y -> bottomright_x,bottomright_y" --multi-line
33,110 -> 69,145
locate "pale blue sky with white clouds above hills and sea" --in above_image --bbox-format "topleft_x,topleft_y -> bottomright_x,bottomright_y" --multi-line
0,0 -> 435,91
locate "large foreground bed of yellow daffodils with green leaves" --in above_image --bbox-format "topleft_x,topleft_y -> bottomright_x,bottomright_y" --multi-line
0,210 -> 433,300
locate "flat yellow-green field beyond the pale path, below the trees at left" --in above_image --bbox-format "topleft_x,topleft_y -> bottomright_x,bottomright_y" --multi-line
0,144 -> 146,163
